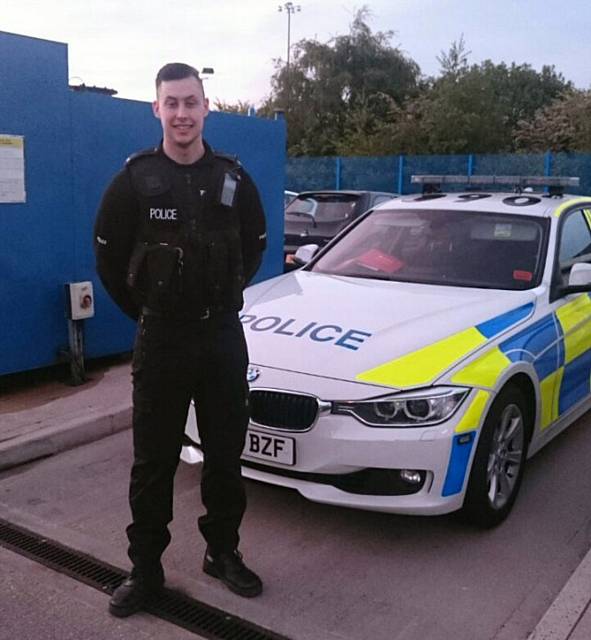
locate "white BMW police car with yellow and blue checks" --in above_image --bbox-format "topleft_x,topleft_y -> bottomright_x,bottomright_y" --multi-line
182,176 -> 591,527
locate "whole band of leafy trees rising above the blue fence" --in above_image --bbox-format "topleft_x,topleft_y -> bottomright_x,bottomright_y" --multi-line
259,13 -> 580,156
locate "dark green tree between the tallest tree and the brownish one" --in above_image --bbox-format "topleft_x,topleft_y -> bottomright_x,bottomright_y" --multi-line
389,49 -> 572,154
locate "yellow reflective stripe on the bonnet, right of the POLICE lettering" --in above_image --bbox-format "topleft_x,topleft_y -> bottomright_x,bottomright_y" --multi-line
356,327 -> 486,387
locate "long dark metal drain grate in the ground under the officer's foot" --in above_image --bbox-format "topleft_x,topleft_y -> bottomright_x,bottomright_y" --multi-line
0,519 -> 289,640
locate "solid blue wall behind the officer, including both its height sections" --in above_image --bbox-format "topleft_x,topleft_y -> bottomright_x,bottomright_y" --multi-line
0,32 -> 285,375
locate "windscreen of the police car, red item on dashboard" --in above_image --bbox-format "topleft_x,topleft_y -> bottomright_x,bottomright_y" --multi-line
310,209 -> 546,290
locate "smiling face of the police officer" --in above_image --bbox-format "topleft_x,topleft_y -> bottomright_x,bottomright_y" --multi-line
152,77 -> 209,149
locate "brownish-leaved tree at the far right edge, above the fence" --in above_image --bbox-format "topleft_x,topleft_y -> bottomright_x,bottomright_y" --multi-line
515,90 -> 591,153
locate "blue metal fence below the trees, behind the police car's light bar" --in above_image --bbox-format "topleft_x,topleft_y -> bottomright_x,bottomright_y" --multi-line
286,152 -> 591,194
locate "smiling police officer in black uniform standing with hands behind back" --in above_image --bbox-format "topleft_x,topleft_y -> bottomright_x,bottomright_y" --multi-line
94,63 -> 265,617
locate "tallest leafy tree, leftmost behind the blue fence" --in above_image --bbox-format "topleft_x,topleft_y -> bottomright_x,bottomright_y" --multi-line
264,7 -> 420,155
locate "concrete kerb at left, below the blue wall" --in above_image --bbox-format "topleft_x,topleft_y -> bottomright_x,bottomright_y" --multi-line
0,402 -> 132,470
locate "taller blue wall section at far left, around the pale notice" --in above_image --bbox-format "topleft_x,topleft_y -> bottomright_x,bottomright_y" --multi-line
0,34 -> 74,372
